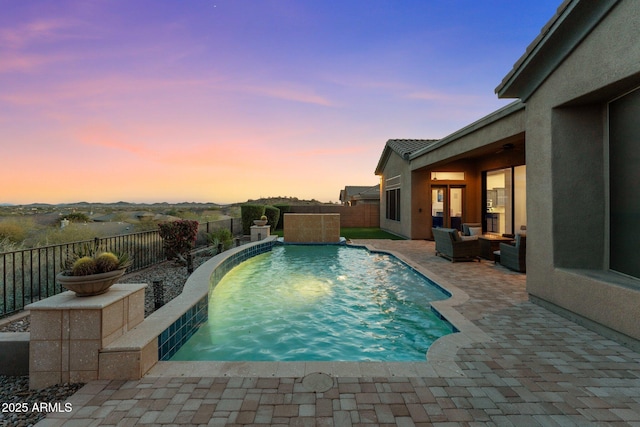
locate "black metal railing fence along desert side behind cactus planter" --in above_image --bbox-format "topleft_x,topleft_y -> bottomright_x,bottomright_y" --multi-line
0,218 -> 242,318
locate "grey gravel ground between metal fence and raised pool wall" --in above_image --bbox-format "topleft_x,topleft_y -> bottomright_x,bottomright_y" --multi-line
0,251 -> 211,427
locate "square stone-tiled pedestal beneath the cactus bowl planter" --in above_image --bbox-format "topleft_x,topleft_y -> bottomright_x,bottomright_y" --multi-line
25,284 -> 147,389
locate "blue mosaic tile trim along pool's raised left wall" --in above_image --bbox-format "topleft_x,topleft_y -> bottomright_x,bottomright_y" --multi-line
158,242 -> 274,360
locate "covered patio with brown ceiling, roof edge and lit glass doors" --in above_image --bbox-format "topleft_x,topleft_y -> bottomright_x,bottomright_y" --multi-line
410,102 -> 526,239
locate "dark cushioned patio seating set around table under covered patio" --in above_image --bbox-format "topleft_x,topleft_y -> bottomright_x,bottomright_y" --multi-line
432,223 -> 527,273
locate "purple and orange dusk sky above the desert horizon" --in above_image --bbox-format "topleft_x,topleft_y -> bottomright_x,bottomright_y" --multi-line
0,0 -> 561,204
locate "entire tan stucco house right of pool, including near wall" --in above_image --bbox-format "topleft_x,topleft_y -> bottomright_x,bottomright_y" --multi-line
376,0 -> 640,348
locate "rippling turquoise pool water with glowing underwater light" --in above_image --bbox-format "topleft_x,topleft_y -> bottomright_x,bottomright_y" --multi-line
171,245 -> 453,361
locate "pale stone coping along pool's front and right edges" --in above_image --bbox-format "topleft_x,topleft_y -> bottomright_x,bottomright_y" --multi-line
145,244 -> 493,378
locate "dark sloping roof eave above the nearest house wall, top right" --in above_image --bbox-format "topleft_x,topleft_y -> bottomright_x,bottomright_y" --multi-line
495,0 -> 619,102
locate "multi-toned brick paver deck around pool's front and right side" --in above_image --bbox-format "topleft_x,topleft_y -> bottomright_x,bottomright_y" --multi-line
37,240 -> 640,427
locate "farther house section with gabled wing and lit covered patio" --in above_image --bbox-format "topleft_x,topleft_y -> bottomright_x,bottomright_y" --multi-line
376,102 -> 526,239
